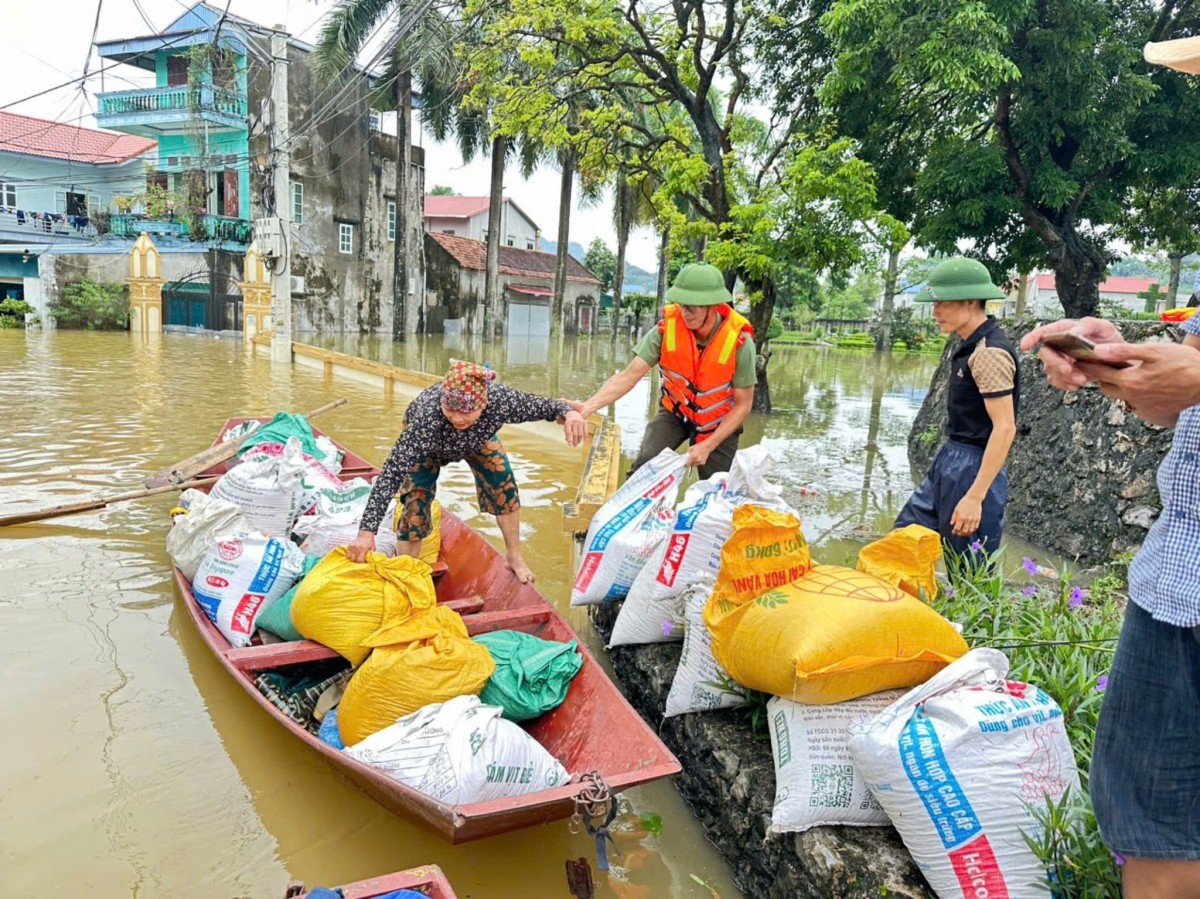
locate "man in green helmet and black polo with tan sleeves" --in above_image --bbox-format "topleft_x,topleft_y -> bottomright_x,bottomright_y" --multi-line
895,257 -> 1020,556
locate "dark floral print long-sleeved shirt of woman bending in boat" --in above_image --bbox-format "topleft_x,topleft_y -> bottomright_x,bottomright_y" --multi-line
359,383 -> 571,532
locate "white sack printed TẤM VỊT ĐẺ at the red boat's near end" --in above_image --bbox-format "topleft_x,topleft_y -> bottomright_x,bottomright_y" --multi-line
346,695 -> 570,805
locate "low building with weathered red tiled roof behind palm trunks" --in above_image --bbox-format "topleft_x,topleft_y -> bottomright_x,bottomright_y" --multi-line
425,232 -> 600,337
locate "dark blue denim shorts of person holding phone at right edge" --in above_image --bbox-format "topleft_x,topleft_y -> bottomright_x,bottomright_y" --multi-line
1090,603 -> 1200,859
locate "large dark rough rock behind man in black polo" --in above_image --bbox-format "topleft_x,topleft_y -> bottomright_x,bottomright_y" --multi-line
908,322 -> 1182,564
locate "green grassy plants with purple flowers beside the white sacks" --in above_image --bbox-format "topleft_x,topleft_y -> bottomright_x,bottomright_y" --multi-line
934,553 -> 1128,899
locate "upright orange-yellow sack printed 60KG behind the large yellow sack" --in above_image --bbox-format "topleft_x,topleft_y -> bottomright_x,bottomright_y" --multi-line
713,503 -> 812,604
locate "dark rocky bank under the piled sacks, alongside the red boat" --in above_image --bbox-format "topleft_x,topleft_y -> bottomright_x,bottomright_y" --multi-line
592,604 -> 934,899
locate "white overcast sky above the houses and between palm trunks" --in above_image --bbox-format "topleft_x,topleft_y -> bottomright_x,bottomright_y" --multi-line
0,0 -> 656,271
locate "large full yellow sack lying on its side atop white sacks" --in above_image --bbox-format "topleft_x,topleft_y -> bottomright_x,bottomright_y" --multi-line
704,565 -> 967,705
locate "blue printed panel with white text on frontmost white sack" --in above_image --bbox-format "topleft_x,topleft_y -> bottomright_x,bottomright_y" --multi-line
900,708 -> 995,849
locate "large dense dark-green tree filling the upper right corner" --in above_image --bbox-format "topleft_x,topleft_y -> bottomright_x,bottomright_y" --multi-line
788,0 -> 1200,316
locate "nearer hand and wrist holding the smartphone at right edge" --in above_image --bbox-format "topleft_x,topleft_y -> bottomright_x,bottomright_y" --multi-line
1079,333 -> 1200,427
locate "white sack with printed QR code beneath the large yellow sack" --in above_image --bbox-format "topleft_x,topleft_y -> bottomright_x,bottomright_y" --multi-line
767,690 -> 901,833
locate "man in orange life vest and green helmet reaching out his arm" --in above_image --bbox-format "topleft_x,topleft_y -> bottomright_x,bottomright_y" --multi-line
575,263 -> 757,478
